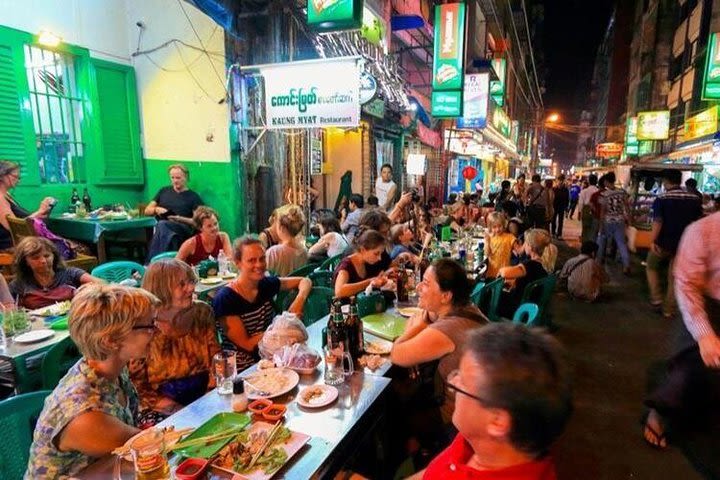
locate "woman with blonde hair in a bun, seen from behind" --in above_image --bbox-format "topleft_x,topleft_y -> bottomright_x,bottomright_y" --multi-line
265,205 -> 308,277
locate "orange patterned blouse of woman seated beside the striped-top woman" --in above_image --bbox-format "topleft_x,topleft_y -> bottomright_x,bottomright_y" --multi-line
130,302 -> 220,411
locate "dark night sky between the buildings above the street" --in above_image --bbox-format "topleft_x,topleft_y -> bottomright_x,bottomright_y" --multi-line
542,0 -> 612,165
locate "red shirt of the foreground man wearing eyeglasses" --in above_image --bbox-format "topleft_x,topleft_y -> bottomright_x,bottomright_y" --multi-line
423,433 -> 557,480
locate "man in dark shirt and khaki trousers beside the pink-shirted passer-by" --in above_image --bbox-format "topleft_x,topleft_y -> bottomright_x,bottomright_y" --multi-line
645,169 -> 703,317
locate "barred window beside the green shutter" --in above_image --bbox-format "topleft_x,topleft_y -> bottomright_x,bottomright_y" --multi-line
25,45 -> 84,184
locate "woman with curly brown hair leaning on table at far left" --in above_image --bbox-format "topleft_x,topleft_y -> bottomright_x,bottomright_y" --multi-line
10,237 -> 104,309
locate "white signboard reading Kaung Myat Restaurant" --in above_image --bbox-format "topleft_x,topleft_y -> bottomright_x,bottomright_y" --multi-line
260,58 -> 360,129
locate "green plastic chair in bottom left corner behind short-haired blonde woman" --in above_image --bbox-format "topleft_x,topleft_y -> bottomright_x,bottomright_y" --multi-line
0,390 -> 50,480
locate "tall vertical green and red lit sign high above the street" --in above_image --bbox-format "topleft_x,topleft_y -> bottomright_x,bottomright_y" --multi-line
432,3 -> 465,90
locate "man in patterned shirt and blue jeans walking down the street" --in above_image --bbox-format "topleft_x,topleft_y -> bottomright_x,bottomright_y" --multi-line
598,172 -> 630,275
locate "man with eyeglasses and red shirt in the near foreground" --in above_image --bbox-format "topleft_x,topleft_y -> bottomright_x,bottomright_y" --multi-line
411,323 -> 572,480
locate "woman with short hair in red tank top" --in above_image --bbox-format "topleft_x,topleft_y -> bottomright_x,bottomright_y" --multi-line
175,205 -> 232,265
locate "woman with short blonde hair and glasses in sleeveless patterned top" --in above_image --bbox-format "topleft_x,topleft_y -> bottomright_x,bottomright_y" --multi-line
25,284 -> 159,479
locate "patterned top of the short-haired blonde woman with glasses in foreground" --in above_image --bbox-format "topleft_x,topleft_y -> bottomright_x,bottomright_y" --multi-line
25,358 -> 138,479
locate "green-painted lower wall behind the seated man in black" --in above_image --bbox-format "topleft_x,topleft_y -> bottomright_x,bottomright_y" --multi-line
143,155 -> 245,239
